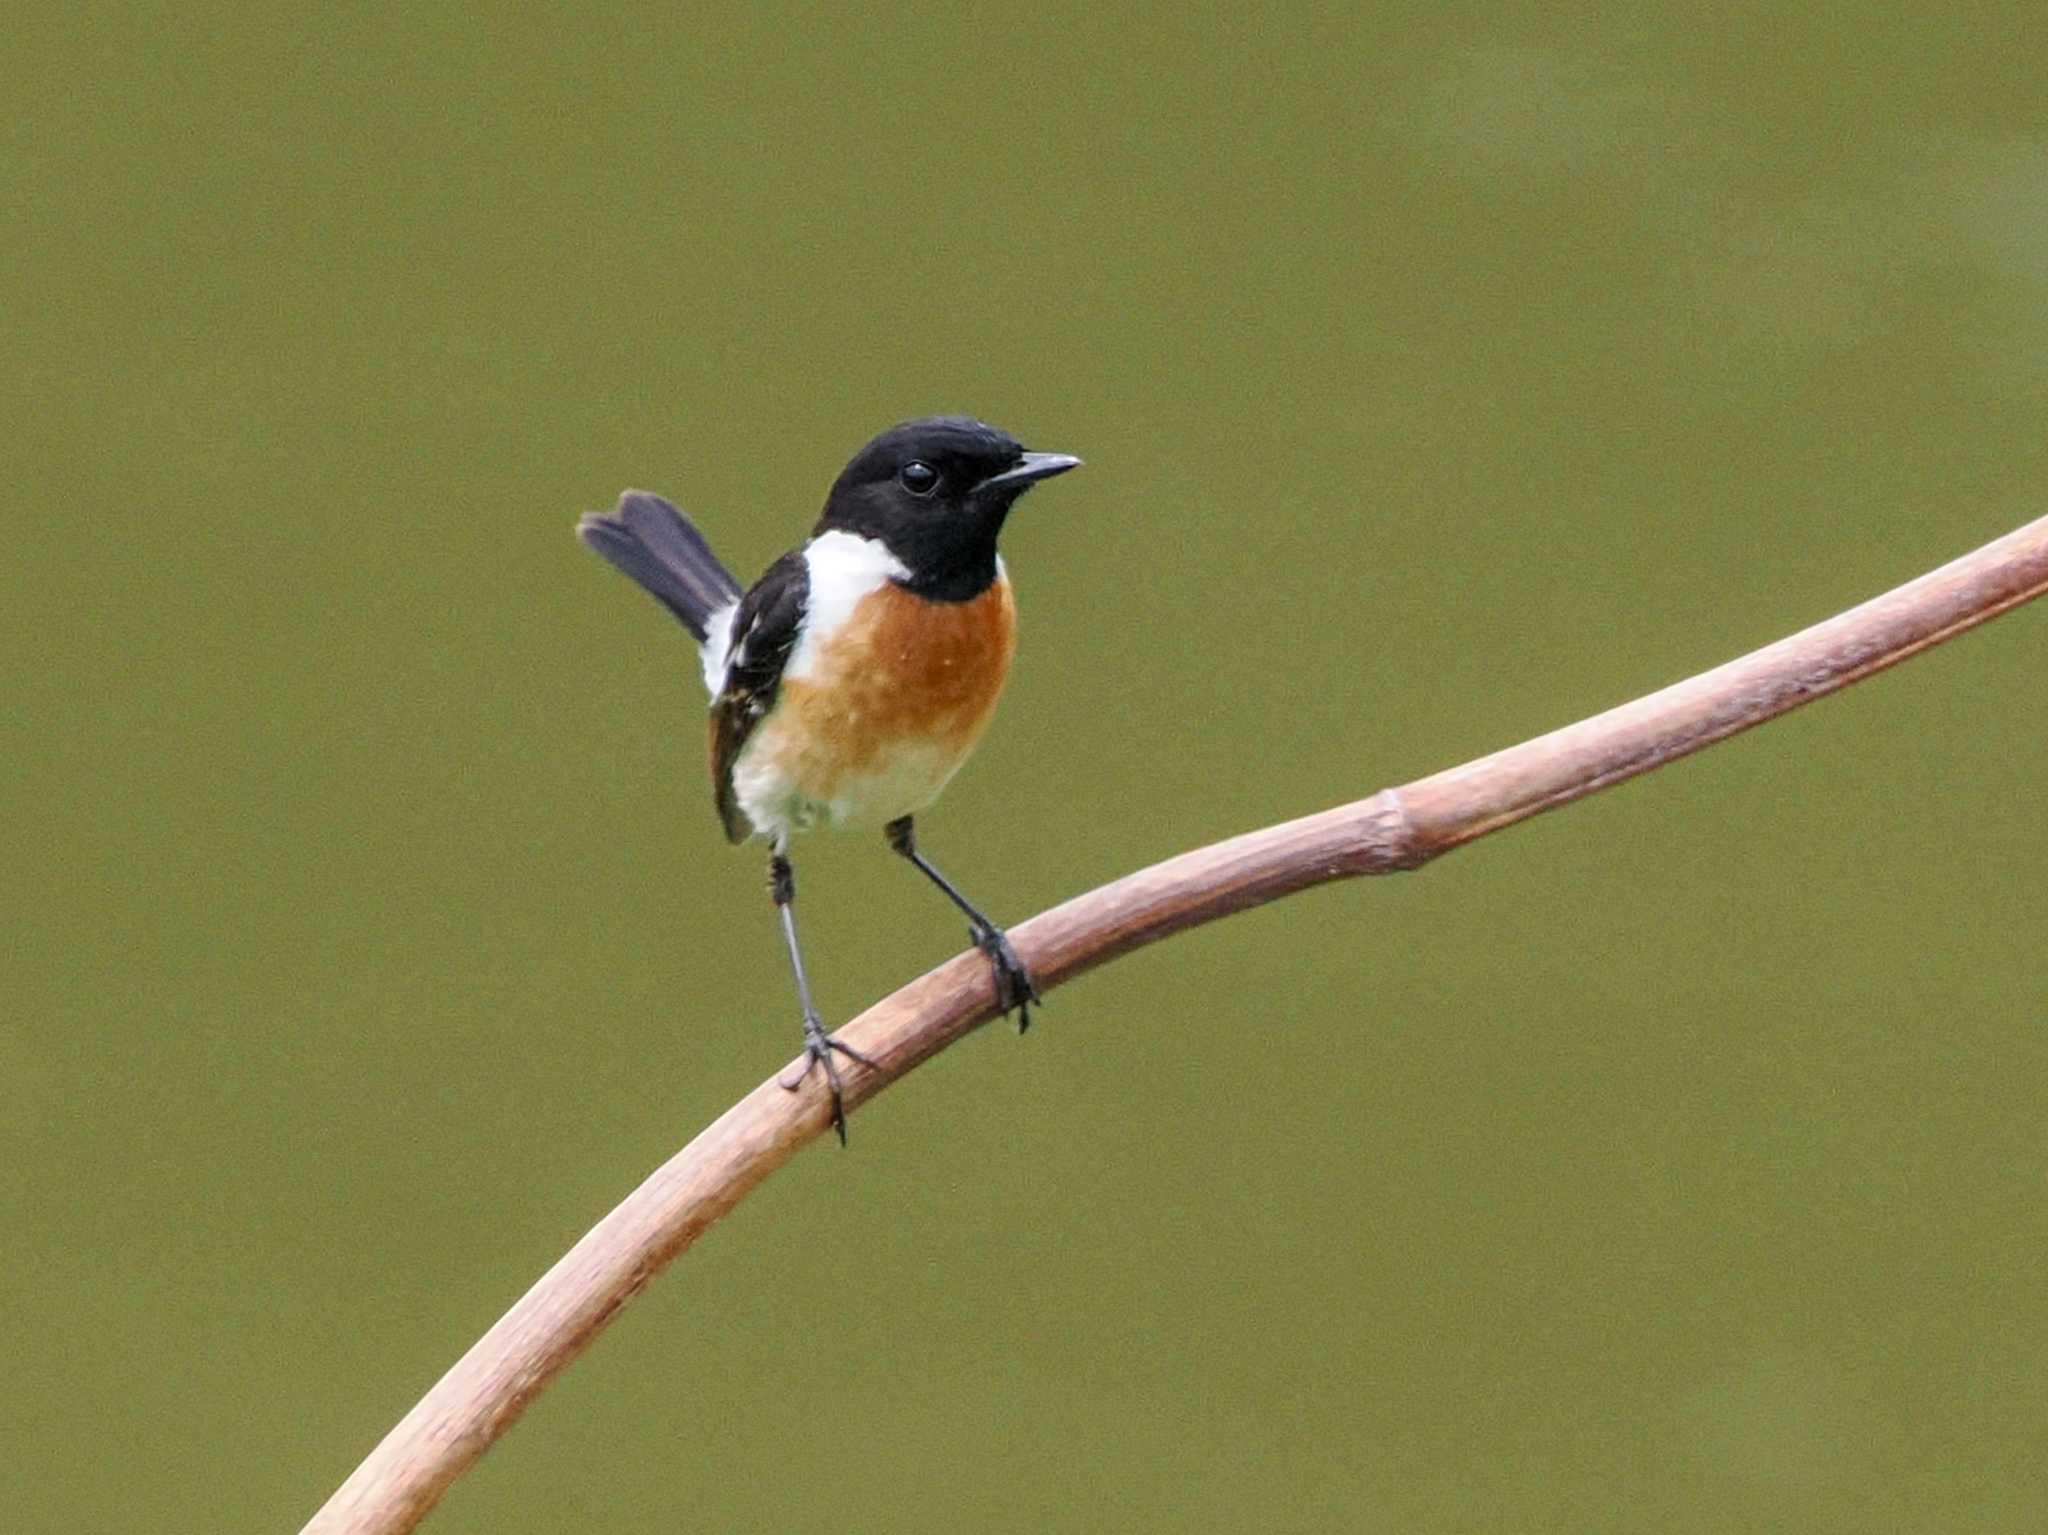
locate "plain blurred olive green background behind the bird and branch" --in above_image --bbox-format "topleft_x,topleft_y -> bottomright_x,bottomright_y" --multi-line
0,0 -> 2048,1535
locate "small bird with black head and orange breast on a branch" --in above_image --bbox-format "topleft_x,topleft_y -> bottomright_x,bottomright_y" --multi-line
575,415 -> 1081,1146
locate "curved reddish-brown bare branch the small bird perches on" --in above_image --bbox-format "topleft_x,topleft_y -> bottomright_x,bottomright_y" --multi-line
305,518 -> 2048,1535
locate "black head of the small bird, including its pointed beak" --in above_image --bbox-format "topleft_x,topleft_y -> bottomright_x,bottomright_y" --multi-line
817,415 -> 1081,602
